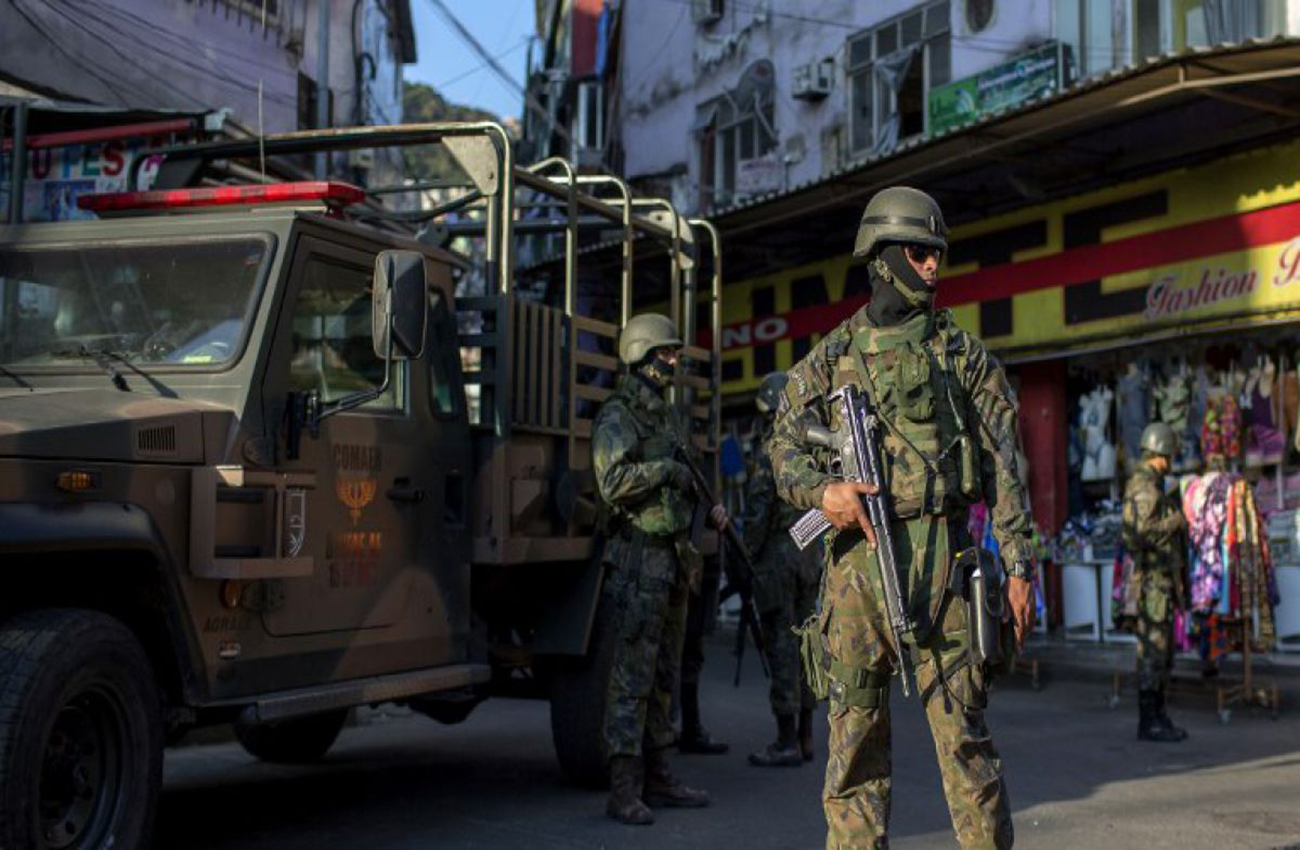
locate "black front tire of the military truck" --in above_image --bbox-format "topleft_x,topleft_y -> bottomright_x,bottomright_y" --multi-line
0,608 -> 163,850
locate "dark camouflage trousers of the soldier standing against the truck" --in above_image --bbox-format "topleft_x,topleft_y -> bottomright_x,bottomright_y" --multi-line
605,533 -> 689,756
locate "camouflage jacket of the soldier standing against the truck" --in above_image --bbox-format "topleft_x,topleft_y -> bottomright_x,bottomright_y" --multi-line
592,374 -> 694,535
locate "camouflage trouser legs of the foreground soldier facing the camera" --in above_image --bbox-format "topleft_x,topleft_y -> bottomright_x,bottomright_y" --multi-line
822,548 -> 1014,850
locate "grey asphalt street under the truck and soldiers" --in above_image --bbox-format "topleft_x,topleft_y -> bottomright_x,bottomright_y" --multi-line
155,638 -> 1300,850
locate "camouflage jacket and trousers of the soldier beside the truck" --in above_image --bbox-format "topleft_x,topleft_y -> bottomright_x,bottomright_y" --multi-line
592,376 -> 698,756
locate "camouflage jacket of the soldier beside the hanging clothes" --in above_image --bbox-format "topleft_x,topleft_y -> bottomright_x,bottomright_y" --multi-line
1123,464 -> 1187,589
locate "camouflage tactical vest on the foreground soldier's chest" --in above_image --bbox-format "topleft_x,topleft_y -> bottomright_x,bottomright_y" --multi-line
831,311 -> 982,520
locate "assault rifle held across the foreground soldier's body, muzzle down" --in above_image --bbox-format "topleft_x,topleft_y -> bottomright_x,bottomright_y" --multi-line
790,383 -> 915,697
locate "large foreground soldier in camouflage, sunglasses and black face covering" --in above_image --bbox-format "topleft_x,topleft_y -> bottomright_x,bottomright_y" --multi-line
770,187 -> 1034,847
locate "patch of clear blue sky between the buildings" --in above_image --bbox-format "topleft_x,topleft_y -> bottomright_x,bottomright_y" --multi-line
406,0 -> 536,118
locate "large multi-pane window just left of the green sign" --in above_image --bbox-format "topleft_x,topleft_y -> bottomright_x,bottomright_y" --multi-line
845,0 -> 953,153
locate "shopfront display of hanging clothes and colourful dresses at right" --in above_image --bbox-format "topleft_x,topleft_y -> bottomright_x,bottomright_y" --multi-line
1049,329 -> 1300,672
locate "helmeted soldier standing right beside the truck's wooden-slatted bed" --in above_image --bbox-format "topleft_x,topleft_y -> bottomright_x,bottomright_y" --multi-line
592,313 -> 727,824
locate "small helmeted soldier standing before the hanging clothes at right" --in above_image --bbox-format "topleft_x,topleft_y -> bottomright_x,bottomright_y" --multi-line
1123,422 -> 1187,743
